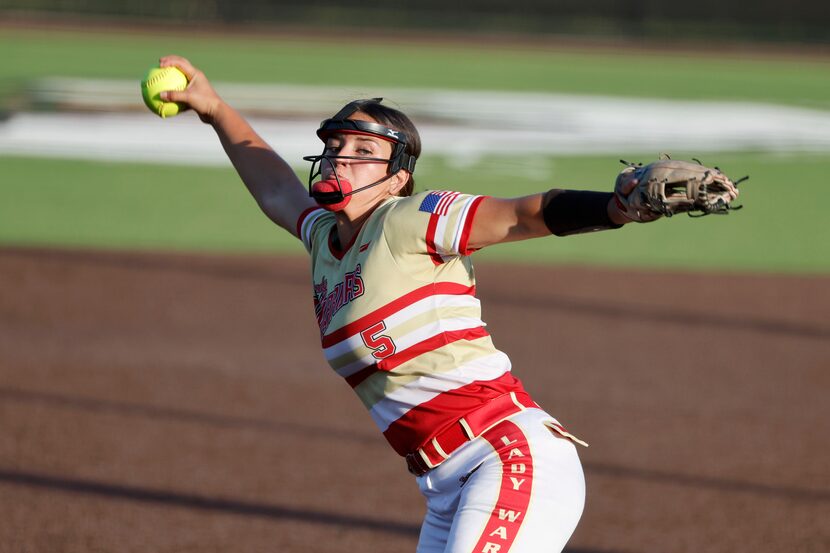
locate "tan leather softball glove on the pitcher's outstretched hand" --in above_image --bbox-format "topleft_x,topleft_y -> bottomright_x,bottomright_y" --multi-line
614,159 -> 749,223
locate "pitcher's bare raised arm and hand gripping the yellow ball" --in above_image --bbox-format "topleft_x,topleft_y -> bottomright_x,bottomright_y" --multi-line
159,56 -> 315,234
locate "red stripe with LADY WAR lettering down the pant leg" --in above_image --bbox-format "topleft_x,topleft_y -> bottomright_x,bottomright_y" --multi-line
473,421 -> 533,553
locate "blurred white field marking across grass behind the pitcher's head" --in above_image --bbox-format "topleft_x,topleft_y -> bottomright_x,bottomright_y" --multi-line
0,83 -> 830,167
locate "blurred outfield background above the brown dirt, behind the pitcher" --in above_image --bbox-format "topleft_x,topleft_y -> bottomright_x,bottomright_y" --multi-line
0,0 -> 830,273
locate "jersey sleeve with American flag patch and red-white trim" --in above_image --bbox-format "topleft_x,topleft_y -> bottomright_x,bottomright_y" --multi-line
386,191 -> 485,265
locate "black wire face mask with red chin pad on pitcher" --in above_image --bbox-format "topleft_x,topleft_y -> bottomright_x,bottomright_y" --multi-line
303,98 -> 415,211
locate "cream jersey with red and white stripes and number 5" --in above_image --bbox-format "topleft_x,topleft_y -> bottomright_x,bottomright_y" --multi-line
297,192 -> 522,455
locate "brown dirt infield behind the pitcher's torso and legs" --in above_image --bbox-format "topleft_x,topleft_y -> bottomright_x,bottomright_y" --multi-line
0,248 -> 830,553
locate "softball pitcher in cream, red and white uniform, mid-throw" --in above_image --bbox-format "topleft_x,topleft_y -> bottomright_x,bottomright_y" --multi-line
161,52 -> 654,553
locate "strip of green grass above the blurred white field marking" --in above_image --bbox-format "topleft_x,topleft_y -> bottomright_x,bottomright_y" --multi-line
0,29 -> 830,109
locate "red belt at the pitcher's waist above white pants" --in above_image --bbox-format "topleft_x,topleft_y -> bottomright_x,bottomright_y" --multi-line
406,392 -> 539,476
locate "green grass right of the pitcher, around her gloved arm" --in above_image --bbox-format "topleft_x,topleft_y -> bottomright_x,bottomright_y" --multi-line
442,152 -> 830,273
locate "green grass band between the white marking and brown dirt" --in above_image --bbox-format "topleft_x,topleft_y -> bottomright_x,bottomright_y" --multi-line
0,152 -> 830,273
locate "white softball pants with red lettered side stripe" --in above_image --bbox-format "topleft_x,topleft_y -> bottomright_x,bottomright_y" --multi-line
417,409 -> 585,553
